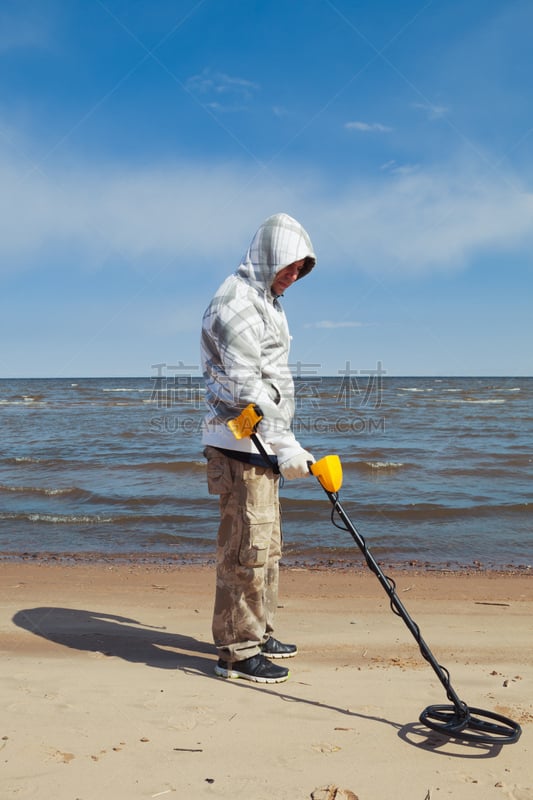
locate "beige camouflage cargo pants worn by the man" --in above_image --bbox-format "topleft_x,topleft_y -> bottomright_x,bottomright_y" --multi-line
204,447 -> 282,661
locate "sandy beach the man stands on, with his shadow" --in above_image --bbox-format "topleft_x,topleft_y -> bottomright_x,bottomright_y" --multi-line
0,561 -> 533,800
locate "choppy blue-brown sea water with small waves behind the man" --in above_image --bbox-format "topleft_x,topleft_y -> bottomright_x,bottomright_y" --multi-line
0,373 -> 533,569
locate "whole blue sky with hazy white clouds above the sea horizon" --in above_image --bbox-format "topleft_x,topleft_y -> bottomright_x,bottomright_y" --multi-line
0,0 -> 533,377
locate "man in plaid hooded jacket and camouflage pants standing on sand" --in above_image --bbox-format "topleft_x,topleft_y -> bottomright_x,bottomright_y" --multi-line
202,214 -> 316,683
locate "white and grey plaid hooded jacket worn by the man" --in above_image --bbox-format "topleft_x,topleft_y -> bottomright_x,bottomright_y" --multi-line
201,214 -> 316,464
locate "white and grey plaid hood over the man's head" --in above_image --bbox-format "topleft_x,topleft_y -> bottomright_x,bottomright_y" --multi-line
237,214 -> 316,290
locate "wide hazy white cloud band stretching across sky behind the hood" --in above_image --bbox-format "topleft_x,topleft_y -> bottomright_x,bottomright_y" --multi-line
0,141 -> 533,276
